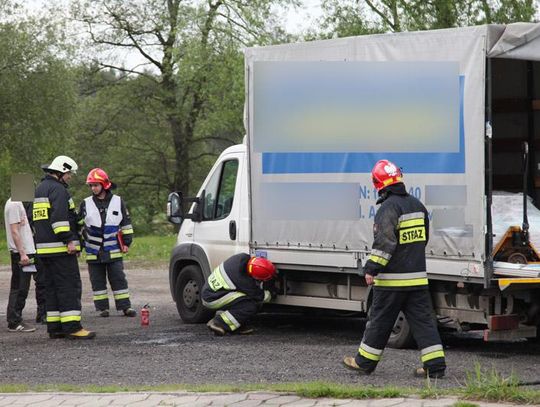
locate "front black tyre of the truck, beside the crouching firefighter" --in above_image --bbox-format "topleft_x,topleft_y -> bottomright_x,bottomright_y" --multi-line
175,265 -> 213,324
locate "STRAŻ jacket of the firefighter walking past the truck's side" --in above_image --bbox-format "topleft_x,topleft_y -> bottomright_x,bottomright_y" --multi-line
364,183 -> 429,290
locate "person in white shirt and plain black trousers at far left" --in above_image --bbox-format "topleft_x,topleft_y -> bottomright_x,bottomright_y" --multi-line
4,198 -> 43,332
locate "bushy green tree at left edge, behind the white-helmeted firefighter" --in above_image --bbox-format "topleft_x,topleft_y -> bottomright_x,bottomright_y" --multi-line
0,0 -> 76,207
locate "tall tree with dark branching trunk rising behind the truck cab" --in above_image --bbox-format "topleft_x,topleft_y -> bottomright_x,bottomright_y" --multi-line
72,0 -> 294,202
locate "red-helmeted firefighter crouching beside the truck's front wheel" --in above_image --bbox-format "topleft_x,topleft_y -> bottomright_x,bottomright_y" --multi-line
202,253 -> 276,336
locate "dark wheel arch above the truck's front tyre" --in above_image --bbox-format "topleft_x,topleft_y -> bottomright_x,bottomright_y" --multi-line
169,243 -> 211,302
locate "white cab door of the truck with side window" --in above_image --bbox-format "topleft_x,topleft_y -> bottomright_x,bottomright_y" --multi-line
193,154 -> 246,270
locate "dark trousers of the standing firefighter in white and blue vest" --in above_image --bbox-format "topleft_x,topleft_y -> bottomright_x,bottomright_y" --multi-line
88,259 -> 131,311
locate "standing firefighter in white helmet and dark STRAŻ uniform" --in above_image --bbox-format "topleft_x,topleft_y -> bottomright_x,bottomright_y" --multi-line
32,155 -> 96,339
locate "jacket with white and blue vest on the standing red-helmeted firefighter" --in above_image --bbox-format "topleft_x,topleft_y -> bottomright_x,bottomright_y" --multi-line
79,191 -> 133,263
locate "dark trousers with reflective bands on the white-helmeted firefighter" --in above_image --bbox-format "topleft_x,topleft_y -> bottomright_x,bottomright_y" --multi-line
39,254 -> 82,334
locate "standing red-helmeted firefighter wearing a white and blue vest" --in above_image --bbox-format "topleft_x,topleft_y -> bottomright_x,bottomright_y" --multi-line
79,168 -> 137,317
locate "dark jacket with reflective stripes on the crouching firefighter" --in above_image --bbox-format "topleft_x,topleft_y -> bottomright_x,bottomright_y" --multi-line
202,253 -> 272,309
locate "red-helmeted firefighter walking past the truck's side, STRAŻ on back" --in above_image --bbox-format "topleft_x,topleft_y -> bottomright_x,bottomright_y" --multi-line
343,160 -> 446,378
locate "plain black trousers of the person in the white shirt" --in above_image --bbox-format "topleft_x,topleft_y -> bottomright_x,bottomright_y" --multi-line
6,253 -> 45,328
